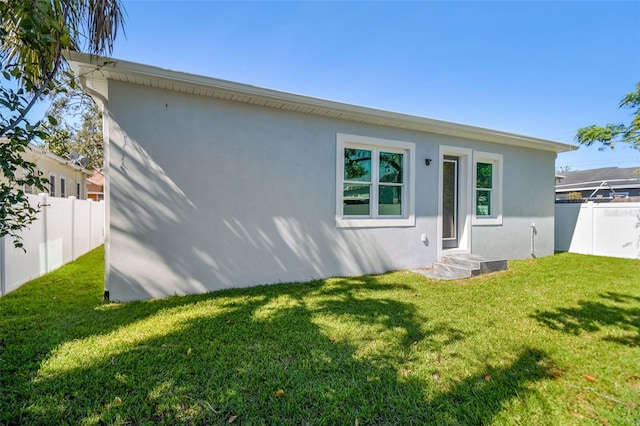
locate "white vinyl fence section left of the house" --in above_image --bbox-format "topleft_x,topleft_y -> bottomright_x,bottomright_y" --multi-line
0,194 -> 105,296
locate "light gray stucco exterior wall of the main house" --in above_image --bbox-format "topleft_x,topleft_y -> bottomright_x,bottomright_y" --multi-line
104,81 -> 555,301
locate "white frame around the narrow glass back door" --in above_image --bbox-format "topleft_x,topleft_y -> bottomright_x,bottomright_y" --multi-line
437,145 -> 473,259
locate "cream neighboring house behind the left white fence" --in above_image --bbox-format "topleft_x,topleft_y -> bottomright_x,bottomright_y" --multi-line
0,139 -> 91,199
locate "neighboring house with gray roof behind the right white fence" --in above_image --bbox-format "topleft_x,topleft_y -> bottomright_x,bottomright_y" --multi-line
556,167 -> 640,201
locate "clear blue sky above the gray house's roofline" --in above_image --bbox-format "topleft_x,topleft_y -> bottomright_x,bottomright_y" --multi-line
107,1 -> 640,169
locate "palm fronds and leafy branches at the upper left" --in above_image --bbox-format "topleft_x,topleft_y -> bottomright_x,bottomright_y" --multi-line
0,0 -> 123,247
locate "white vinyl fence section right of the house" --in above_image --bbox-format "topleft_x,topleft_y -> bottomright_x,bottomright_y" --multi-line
555,202 -> 640,259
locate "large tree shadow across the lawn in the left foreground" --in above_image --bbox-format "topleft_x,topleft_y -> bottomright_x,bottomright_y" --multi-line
0,250 -> 551,424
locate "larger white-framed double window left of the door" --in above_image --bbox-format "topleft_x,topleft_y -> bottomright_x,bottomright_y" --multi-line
336,134 -> 415,227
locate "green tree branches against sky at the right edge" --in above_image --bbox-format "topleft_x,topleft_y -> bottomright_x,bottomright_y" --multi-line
575,82 -> 640,149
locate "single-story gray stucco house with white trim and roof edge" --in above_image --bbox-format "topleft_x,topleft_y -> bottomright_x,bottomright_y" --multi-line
69,53 -> 571,301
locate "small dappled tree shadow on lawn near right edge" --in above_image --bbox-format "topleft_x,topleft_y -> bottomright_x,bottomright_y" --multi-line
532,292 -> 640,346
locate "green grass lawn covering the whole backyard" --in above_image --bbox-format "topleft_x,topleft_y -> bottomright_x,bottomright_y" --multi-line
0,249 -> 640,425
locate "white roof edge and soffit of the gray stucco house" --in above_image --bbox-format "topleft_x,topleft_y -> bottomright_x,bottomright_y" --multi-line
66,52 -> 575,153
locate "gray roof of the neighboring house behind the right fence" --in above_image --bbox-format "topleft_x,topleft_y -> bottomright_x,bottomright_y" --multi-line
556,167 -> 640,192
